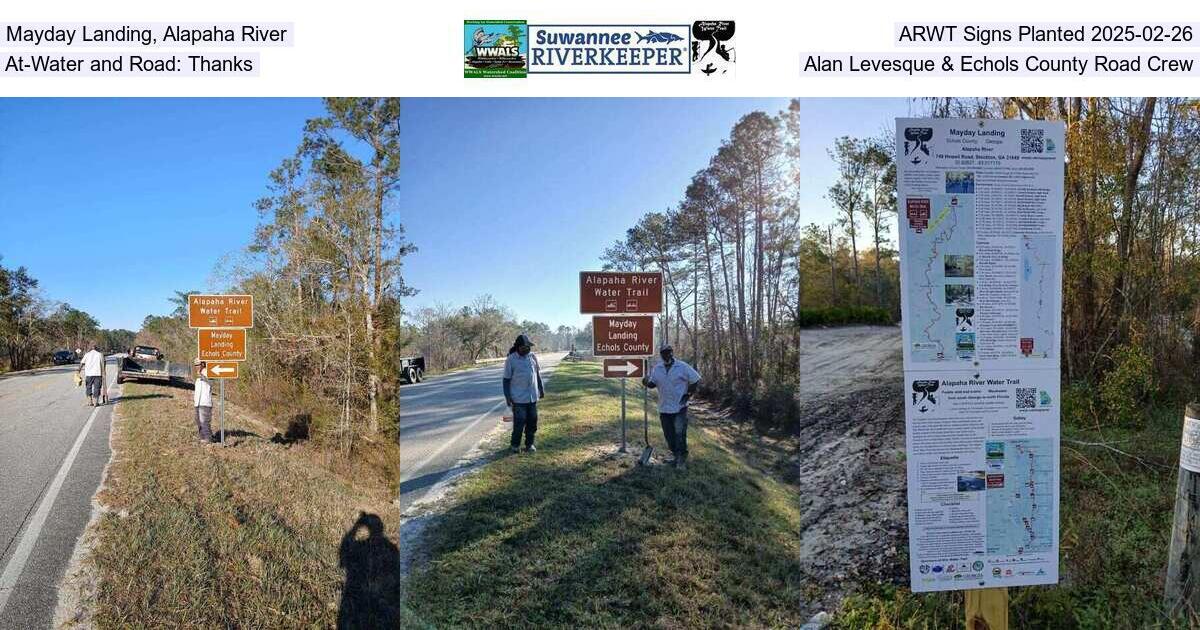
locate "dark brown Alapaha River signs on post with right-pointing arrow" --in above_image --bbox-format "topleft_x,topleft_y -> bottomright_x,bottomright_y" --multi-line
580,271 -> 662,452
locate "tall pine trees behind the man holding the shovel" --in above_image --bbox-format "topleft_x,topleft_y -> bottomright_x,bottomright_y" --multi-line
602,101 -> 800,428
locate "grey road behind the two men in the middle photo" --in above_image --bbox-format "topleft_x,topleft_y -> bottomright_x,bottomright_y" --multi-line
400,353 -> 566,512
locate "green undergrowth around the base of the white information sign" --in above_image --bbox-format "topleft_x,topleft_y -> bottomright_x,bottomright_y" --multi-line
838,396 -> 1200,629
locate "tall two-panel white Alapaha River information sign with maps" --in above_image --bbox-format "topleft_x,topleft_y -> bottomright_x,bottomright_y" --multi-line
896,119 -> 1066,592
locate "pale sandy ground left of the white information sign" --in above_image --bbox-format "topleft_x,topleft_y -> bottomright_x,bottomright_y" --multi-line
796,326 -> 907,610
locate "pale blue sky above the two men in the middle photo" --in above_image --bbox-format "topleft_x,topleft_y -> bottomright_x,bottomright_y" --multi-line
400,98 -> 787,325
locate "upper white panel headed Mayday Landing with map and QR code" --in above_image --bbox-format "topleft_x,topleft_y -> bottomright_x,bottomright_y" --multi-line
896,119 -> 1066,370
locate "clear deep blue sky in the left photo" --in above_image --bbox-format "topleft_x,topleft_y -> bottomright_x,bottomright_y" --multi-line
0,98 -> 323,330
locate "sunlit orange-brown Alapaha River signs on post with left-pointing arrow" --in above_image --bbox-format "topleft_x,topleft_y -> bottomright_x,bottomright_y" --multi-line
187,294 -> 254,446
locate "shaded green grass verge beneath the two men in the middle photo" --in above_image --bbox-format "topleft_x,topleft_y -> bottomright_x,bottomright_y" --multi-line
407,362 -> 806,628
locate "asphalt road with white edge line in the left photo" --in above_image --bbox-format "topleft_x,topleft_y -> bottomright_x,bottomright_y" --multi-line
0,359 -> 116,630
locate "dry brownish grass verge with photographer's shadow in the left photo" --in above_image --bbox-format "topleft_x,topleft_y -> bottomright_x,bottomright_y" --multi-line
90,384 -> 398,628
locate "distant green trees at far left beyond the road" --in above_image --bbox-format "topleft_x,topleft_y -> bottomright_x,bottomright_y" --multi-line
0,258 -> 134,372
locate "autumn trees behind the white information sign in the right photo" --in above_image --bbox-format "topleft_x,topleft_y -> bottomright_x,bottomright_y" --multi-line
800,97 -> 1200,417
